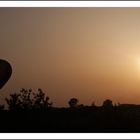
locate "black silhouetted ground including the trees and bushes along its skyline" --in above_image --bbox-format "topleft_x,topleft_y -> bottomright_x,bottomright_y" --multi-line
0,89 -> 140,133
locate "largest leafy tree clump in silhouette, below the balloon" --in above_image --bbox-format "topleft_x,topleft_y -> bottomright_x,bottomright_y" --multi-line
6,88 -> 52,110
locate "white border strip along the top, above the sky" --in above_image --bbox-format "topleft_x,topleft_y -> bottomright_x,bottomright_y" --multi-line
0,1 -> 140,7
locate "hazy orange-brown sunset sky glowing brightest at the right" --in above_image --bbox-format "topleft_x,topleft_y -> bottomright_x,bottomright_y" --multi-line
0,8 -> 140,106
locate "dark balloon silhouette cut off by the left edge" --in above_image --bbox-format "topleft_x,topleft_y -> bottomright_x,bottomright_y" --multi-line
0,59 -> 12,89
